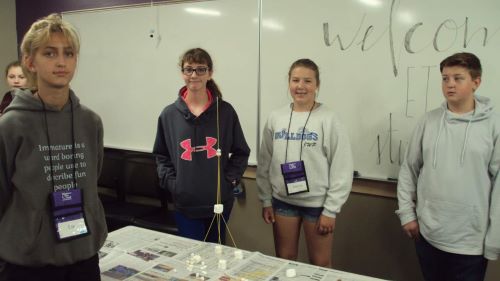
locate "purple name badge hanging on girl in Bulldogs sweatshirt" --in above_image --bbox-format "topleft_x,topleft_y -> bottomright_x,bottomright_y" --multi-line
281,161 -> 309,195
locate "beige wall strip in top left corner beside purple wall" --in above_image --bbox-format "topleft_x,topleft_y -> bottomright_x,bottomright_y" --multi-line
0,0 -> 17,93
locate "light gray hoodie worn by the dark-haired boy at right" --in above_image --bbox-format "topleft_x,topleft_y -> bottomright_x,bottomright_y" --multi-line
396,95 -> 500,260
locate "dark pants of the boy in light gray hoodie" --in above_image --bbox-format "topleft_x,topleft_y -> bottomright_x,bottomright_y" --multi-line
415,235 -> 488,281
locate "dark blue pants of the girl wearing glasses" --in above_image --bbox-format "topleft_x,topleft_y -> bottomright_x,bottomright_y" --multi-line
175,205 -> 232,244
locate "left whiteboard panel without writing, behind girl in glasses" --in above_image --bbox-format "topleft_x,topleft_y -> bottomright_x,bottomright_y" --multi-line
64,0 -> 259,164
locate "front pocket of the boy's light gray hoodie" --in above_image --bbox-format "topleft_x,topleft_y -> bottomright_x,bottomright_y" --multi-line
418,200 -> 483,248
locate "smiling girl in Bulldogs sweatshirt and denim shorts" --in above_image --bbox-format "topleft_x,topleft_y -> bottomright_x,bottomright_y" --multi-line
257,59 -> 353,267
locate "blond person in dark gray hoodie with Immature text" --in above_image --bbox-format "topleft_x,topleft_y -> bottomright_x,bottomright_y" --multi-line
0,14 -> 107,281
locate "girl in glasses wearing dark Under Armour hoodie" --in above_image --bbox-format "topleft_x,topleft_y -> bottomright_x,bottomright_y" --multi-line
153,48 -> 250,243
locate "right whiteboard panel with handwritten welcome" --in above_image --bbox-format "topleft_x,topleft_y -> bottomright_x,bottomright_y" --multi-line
260,0 -> 500,179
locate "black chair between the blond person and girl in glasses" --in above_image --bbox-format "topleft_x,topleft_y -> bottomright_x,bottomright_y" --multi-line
99,150 -> 177,234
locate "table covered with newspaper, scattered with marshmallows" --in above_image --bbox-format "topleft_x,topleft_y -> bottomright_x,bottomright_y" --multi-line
99,226 -> 388,281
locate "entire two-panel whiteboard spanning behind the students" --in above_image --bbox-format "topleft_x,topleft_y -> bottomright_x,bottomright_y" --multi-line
64,0 -> 500,179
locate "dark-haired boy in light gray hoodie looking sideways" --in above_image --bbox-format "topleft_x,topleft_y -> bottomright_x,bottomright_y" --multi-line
396,53 -> 500,281
